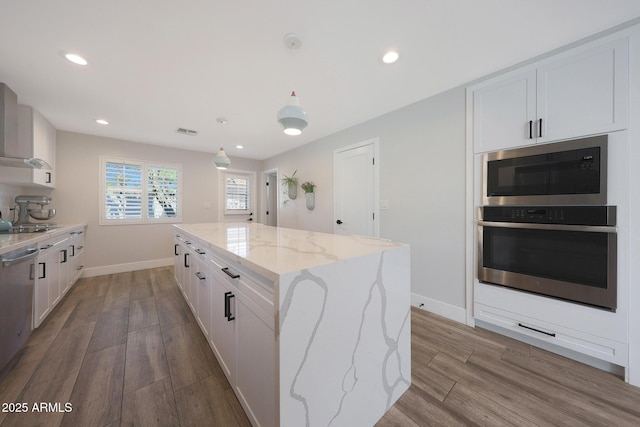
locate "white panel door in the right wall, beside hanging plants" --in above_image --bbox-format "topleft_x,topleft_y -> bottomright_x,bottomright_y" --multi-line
333,139 -> 379,237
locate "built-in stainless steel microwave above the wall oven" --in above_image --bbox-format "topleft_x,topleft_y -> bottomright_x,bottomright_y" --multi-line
482,135 -> 607,206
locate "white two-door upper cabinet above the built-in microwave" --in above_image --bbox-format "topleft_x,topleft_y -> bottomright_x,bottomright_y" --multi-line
467,38 -> 629,153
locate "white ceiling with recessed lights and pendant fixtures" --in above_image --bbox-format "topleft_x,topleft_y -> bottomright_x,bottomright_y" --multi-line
0,0 -> 640,159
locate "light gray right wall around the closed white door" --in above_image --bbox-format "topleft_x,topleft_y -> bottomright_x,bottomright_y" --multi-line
262,87 -> 465,314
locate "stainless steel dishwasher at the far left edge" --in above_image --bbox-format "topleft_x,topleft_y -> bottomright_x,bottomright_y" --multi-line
0,247 -> 39,369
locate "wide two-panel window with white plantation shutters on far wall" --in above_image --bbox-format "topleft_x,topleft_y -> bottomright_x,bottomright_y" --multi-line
100,157 -> 182,225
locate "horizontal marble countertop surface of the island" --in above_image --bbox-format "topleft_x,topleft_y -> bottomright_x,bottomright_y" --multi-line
174,223 -> 404,280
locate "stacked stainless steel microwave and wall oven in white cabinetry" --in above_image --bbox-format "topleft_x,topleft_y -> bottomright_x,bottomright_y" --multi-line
478,135 -> 617,311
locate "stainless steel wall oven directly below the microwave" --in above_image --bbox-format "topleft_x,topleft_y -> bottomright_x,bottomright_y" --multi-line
478,206 -> 617,311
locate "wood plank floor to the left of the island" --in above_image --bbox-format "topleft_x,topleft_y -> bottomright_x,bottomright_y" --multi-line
0,267 -> 250,427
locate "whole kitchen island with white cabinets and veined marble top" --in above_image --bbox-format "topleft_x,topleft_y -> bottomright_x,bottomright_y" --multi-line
174,223 -> 411,427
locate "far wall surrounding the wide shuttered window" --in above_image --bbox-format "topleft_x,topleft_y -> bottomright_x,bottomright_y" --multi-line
52,131 -> 260,272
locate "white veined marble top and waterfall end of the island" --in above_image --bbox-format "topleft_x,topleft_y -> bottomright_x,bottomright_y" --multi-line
175,224 -> 411,427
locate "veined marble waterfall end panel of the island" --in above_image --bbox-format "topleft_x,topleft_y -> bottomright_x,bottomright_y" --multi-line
279,246 -> 411,427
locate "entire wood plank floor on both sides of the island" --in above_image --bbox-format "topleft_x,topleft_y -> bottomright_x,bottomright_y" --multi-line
0,267 -> 640,427
